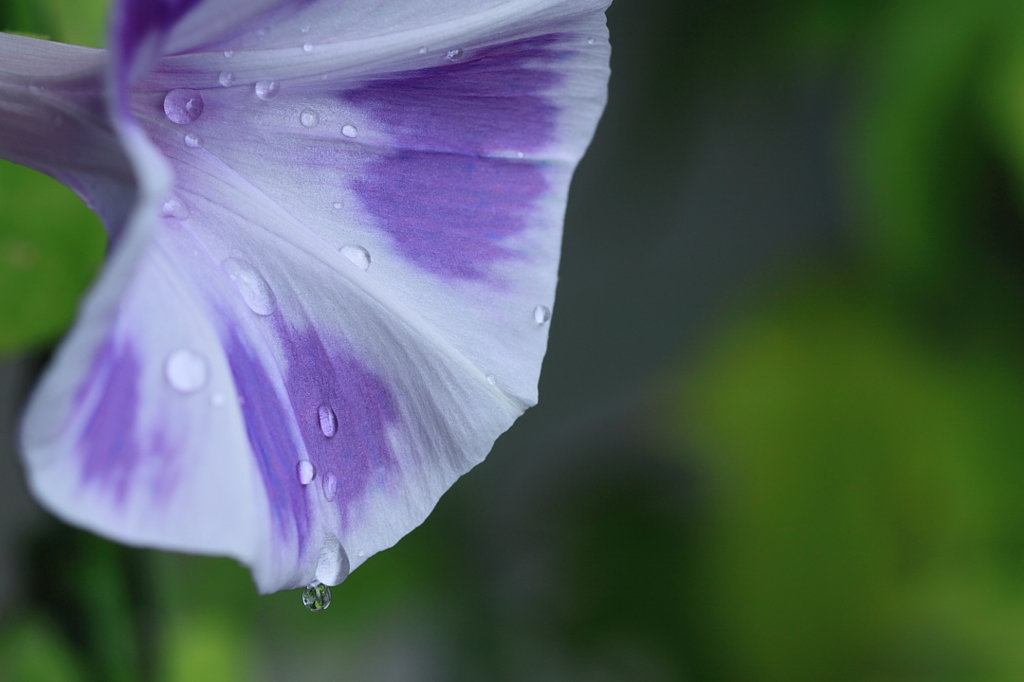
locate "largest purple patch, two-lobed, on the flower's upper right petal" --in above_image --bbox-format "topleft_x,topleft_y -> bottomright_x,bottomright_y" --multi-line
343,35 -> 562,280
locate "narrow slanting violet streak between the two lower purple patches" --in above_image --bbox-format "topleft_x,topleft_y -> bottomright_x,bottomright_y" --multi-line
224,333 -> 309,552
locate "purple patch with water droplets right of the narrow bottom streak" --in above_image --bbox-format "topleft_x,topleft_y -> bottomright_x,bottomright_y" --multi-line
281,329 -> 397,520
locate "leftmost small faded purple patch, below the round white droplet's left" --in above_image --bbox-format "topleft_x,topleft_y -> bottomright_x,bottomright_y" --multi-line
75,339 -> 142,504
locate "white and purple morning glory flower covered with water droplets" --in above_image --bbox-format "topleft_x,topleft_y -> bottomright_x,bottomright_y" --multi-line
0,0 -> 609,592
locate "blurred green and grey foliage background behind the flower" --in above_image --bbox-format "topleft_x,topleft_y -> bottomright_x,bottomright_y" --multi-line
0,0 -> 1024,682
